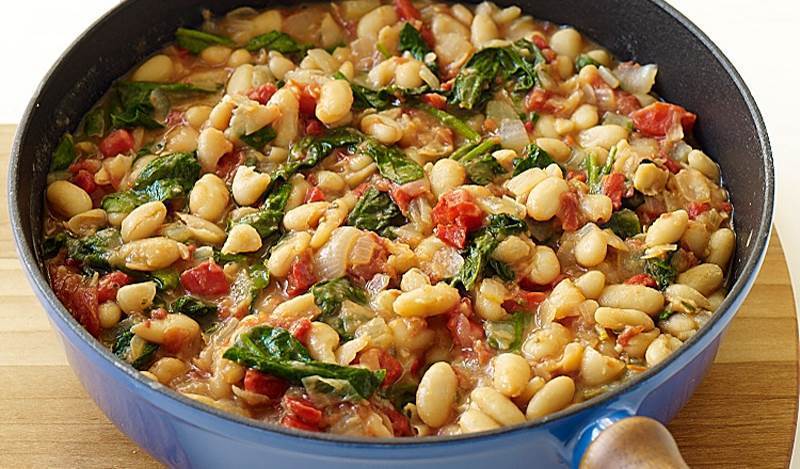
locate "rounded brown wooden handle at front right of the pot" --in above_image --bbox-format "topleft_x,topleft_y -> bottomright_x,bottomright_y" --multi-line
580,417 -> 689,469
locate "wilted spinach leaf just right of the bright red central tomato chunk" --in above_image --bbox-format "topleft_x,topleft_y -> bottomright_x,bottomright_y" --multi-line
450,213 -> 528,290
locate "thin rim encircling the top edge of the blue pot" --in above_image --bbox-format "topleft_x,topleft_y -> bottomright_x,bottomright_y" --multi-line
8,0 -> 775,448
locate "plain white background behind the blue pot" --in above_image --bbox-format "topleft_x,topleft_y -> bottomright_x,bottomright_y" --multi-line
0,0 -> 800,466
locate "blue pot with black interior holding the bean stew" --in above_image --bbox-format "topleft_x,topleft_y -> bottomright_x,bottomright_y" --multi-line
9,0 -> 774,469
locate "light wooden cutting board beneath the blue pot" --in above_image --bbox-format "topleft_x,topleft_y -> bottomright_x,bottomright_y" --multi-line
0,125 -> 798,468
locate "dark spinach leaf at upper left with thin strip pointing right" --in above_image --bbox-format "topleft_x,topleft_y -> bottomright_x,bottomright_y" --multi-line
109,81 -> 217,129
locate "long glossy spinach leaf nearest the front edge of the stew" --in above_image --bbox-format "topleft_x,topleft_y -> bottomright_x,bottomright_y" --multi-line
223,326 -> 386,398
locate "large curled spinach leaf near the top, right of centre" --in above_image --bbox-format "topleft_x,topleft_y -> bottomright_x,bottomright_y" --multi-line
450,39 -> 544,109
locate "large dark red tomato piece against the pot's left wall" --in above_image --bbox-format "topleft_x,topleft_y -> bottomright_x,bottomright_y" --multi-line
48,264 -> 101,337
